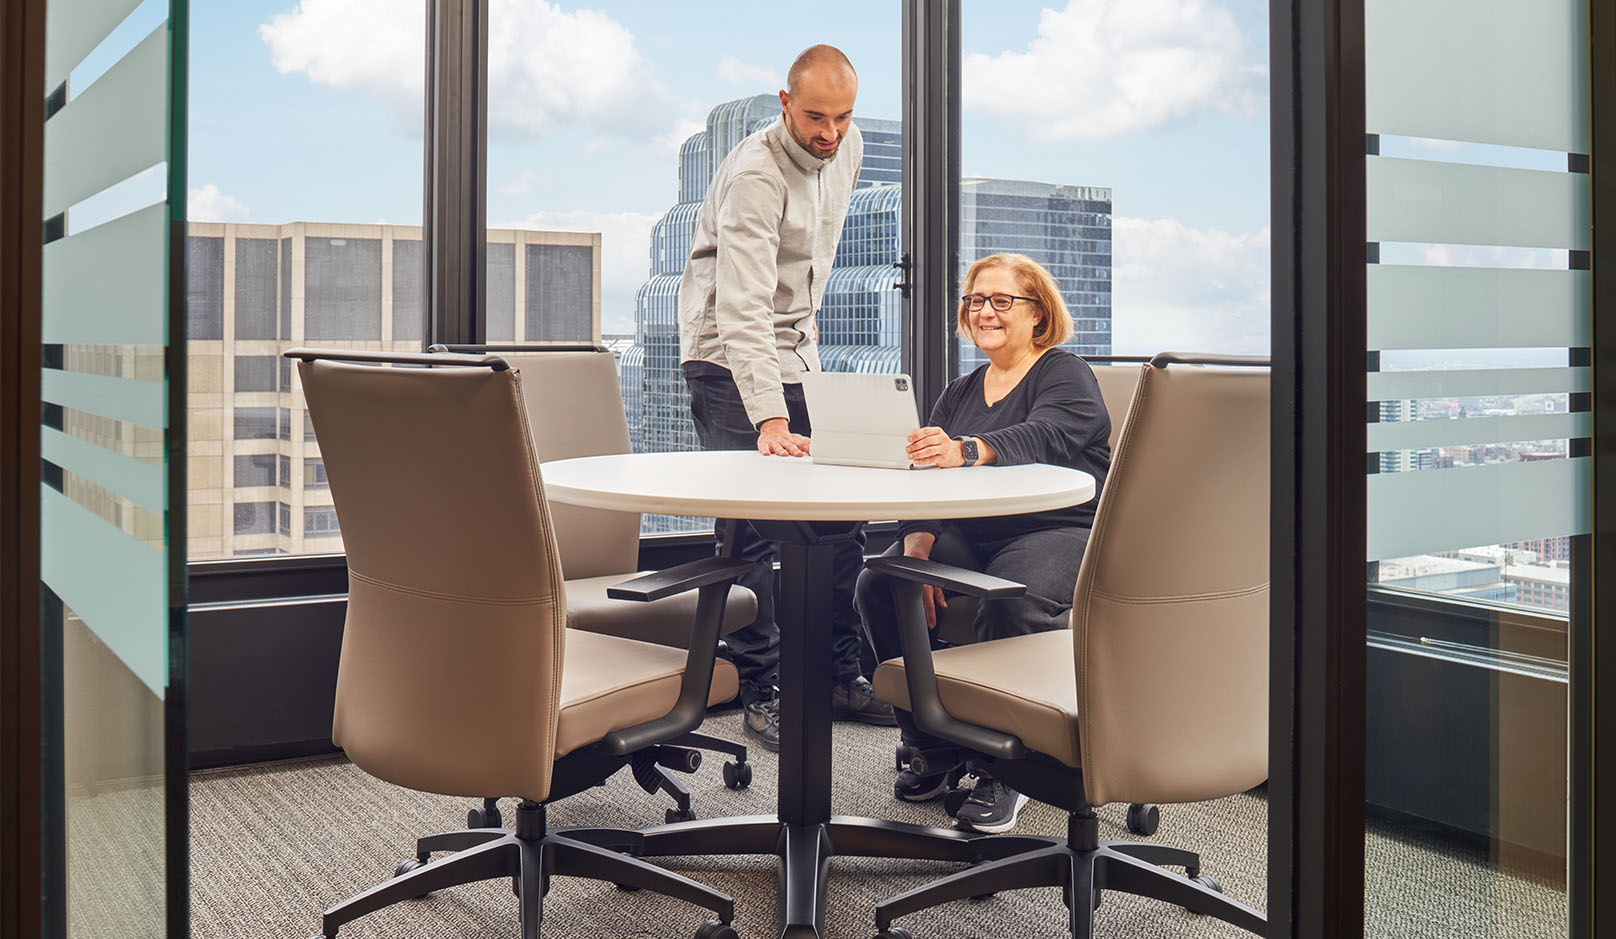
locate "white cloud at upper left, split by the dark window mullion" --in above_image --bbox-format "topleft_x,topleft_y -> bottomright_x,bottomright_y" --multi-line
259,0 -> 671,137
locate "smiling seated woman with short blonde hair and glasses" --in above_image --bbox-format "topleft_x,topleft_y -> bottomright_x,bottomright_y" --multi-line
855,254 -> 1110,832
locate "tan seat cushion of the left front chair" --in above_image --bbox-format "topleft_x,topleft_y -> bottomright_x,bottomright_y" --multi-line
556,627 -> 740,756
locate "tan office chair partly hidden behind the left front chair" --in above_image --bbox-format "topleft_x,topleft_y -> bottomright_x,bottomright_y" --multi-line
431,346 -> 758,827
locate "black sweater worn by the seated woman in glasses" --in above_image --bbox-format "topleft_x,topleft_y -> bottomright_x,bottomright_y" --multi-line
898,349 -> 1110,543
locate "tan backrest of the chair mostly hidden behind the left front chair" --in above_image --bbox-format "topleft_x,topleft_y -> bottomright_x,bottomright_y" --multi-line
490,349 -> 640,580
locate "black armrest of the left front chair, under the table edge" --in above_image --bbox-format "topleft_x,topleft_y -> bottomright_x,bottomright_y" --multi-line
601,558 -> 751,755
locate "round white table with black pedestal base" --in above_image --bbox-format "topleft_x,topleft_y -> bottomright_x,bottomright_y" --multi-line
540,451 -> 1094,939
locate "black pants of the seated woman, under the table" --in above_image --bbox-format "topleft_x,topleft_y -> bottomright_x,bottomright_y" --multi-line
855,522 -> 1089,748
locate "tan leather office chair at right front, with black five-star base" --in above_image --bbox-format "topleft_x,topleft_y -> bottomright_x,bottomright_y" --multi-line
869,356 -> 1269,939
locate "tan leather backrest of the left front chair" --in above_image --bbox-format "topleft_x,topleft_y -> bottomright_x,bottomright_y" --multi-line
299,360 -> 566,800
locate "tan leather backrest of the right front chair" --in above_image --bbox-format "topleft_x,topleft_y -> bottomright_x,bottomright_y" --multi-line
1071,358 -> 1269,805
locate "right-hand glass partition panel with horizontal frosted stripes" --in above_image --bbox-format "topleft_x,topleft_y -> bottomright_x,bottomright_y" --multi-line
1364,0 -> 1593,937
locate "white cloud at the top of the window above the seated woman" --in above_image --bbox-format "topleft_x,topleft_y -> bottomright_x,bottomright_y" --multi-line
962,0 -> 1267,141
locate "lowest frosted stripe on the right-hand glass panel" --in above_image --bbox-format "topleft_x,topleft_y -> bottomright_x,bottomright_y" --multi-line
1366,457 -> 1593,561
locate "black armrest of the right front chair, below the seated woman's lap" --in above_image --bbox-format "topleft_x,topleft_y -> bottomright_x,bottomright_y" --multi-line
865,558 -> 1026,760
